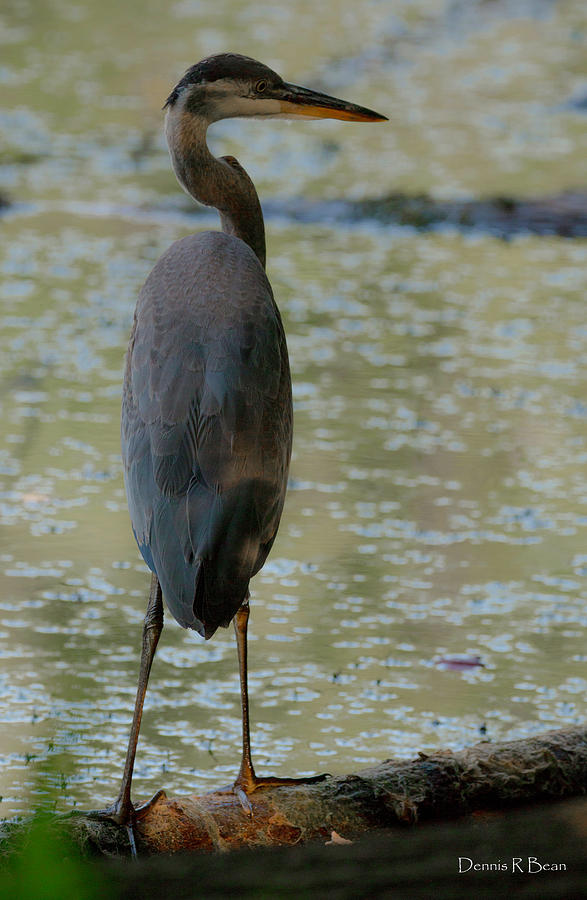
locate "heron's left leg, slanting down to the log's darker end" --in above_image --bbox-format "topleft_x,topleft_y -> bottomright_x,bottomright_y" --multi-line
88,575 -> 163,856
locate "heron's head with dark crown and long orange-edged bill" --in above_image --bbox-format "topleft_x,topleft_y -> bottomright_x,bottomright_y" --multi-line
164,53 -> 386,123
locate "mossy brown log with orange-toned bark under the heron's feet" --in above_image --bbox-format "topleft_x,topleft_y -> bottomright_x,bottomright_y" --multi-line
69,727 -> 587,856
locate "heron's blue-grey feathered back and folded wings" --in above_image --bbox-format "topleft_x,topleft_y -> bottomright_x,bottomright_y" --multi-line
122,233 -> 291,636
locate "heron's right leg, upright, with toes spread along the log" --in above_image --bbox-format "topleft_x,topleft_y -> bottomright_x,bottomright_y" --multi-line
232,596 -> 329,816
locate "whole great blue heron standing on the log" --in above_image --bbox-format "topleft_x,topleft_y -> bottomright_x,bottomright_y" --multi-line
103,53 -> 385,843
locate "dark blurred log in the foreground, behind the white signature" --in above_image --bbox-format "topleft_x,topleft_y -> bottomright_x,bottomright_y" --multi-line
97,799 -> 587,900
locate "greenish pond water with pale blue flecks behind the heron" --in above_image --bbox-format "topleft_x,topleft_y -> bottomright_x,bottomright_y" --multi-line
0,0 -> 587,816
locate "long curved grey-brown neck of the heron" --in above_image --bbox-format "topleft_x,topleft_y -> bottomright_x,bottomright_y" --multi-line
165,109 -> 265,267
